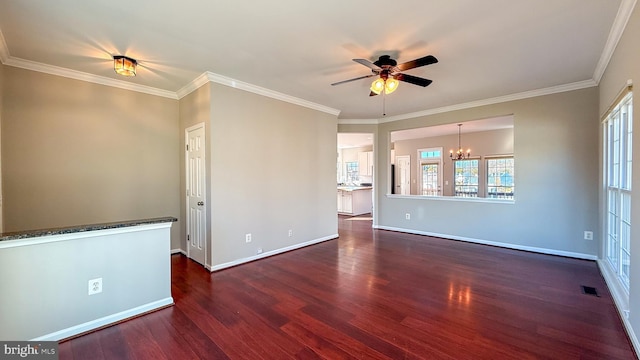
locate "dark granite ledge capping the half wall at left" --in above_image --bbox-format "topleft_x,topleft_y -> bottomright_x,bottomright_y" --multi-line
0,216 -> 178,241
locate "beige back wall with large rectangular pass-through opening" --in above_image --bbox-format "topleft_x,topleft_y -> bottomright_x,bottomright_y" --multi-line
376,87 -> 599,258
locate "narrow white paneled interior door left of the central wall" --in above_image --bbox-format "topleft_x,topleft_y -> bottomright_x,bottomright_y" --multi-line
186,124 -> 207,265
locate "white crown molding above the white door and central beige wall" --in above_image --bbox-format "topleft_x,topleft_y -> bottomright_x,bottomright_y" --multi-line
177,71 -> 340,116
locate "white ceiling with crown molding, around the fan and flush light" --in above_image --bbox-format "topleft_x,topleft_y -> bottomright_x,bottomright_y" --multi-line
0,0 -> 634,119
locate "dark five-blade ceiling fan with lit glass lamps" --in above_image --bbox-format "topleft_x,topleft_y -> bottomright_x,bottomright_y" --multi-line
331,55 -> 438,96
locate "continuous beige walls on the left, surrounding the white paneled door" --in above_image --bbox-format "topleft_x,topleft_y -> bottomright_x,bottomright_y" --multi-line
2,67 -> 337,267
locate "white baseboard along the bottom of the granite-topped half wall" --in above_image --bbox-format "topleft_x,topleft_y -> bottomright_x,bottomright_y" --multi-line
30,297 -> 173,341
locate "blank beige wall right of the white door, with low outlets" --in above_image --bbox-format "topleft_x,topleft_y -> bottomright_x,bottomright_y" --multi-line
208,84 -> 338,267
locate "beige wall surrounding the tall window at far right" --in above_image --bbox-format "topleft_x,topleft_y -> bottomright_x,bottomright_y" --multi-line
593,5 -> 640,352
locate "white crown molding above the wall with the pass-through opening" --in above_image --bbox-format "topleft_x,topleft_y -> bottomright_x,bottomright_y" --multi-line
378,79 -> 598,124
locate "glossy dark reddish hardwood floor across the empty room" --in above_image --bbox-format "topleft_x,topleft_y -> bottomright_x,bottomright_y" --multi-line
59,217 -> 635,359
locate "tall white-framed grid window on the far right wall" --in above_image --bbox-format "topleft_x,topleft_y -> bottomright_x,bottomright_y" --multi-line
603,92 -> 633,291
